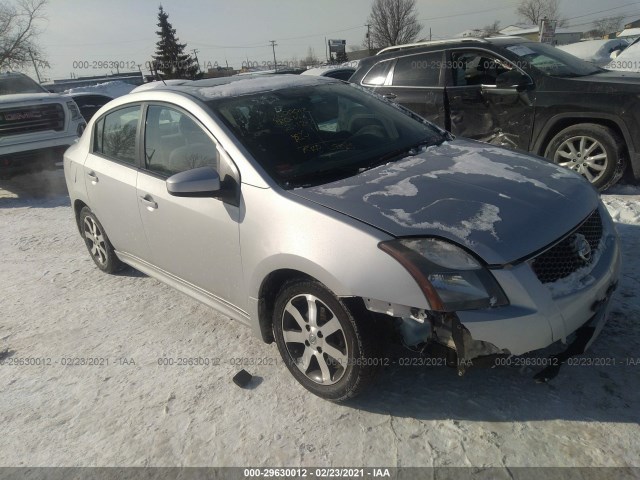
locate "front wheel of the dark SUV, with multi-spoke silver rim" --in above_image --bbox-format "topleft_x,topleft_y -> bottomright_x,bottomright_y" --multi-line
544,123 -> 626,191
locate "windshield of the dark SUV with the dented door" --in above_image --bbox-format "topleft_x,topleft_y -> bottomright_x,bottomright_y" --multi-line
506,42 -> 604,77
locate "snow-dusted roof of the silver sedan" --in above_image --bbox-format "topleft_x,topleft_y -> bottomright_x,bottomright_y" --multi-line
133,74 -> 341,101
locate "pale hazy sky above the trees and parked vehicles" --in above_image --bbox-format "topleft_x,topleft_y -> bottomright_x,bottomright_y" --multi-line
28,0 -> 640,79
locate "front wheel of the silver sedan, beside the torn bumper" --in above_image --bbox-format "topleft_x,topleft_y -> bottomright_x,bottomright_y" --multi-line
273,280 -> 383,402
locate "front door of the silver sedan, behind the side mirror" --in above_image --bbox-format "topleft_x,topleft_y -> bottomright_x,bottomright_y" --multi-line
137,104 -> 247,309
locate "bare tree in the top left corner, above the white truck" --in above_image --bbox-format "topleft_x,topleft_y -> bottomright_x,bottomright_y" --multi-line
0,0 -> 49,70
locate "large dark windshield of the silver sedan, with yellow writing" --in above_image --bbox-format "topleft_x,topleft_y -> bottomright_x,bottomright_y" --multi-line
209,84 -> 446,188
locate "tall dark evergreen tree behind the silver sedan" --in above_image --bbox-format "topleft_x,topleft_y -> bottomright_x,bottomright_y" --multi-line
153,5 -> 202,79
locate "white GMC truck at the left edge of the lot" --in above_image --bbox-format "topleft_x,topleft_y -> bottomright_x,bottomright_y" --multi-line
0,73 -> 86,176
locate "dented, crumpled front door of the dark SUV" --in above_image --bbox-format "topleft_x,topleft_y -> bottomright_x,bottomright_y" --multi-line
446,49 -> 535,151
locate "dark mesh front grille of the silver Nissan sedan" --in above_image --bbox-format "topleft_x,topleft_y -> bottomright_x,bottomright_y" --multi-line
531,209 -> 602,283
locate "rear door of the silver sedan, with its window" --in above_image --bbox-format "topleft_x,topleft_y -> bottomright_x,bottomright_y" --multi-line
84,104 -> 149,260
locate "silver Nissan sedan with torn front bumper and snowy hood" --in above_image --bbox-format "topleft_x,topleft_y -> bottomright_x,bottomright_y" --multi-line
64,75 -> 620,401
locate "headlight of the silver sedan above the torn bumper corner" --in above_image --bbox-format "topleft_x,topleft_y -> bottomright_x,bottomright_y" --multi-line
378,238 -> 509,312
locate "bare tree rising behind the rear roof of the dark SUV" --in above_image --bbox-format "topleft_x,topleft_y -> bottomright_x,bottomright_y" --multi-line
368,0 -> 422,48
